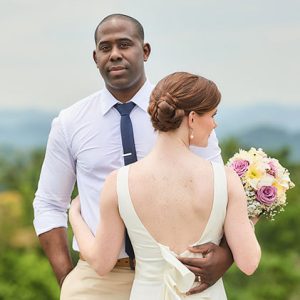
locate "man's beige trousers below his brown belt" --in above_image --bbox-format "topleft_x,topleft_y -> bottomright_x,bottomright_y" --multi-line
60,260 -> 134,300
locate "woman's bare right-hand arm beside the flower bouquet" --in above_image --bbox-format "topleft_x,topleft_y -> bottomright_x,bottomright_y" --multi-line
224,168 -> 261,275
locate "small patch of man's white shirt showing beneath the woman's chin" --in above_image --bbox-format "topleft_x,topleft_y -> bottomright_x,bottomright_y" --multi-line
191,130 -> 224,164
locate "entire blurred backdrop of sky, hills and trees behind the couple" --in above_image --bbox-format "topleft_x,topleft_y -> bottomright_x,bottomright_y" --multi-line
0,0 -> 300,300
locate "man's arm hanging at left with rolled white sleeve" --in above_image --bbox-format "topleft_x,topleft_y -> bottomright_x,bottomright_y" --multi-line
33,118 -> 76,285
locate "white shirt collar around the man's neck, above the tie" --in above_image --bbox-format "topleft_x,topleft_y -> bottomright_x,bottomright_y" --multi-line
101,80 -> 153,115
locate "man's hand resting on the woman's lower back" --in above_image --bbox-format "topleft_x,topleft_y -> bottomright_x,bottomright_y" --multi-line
178,238 -> 233,295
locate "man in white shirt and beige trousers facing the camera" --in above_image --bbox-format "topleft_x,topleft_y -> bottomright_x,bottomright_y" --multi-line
34,14 -> 232,300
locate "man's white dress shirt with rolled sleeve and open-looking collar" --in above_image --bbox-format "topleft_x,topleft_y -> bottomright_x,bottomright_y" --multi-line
33,81 -> 222,258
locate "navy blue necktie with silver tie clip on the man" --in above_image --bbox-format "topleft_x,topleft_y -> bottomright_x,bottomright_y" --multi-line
114,102 -> 137,259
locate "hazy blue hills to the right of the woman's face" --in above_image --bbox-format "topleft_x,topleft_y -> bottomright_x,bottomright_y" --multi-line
216,105 -> 300,161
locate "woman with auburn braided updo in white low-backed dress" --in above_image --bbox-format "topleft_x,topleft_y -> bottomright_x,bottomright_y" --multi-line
70,72 -> 260,300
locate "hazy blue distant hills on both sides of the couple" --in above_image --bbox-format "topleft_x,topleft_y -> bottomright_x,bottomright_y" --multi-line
0,105 -> 300,161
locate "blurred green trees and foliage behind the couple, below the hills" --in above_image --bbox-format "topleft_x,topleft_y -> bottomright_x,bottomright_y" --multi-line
0,139 -> 300,300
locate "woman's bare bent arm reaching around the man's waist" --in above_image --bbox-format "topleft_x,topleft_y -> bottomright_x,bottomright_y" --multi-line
69,171 -> 125,276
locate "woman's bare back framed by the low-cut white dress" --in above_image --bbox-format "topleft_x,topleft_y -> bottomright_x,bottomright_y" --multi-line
129,153 -> 213,254
